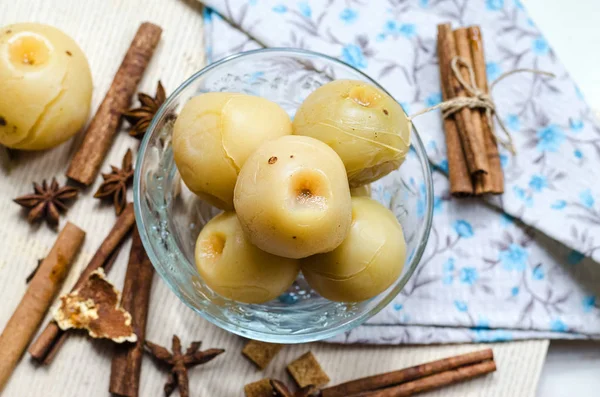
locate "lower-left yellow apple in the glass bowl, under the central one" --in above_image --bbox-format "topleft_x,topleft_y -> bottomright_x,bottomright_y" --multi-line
195,212 -> 299,303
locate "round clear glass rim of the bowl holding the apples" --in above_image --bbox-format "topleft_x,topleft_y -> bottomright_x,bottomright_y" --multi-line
133,48 -> 433,344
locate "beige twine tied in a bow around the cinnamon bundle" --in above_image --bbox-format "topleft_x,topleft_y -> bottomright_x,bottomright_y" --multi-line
409,56 -> 555,155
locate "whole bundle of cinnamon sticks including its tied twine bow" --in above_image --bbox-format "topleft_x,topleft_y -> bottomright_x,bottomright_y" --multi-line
434,23 -> 554,197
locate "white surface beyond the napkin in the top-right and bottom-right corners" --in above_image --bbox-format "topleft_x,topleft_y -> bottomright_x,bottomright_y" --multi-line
523,0 -> 600,397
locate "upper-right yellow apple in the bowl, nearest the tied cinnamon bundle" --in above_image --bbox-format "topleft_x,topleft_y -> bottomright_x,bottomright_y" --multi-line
293,80 -> 411,187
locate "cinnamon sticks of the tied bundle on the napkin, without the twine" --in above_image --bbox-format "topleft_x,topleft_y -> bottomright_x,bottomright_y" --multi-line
438,23 -> 504,197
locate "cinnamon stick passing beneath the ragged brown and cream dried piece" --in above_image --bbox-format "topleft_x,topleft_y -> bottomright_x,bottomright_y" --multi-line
29,203 -> 135,365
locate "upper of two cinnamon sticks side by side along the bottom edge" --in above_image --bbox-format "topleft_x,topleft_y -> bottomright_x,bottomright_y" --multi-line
321,349 -> 494,397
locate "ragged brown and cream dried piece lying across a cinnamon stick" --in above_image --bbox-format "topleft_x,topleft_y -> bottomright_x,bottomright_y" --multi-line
54,268 -> 137,343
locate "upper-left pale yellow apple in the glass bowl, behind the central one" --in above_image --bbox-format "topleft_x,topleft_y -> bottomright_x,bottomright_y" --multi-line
173,92 -> 292,210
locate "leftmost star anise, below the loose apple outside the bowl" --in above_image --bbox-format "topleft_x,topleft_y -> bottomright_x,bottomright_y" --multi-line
13,178 -> 78,226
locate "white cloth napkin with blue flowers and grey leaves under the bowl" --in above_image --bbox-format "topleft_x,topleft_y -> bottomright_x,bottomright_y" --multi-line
203,0 -> 600,343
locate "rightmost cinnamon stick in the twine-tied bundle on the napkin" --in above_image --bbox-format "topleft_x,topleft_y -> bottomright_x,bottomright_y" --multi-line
467,26 -> 504,194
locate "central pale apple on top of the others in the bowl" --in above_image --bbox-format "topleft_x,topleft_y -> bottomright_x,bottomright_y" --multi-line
234,136 -> 352,258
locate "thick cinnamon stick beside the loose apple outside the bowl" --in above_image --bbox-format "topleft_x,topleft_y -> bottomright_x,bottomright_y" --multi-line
67,22 -> 162,186
